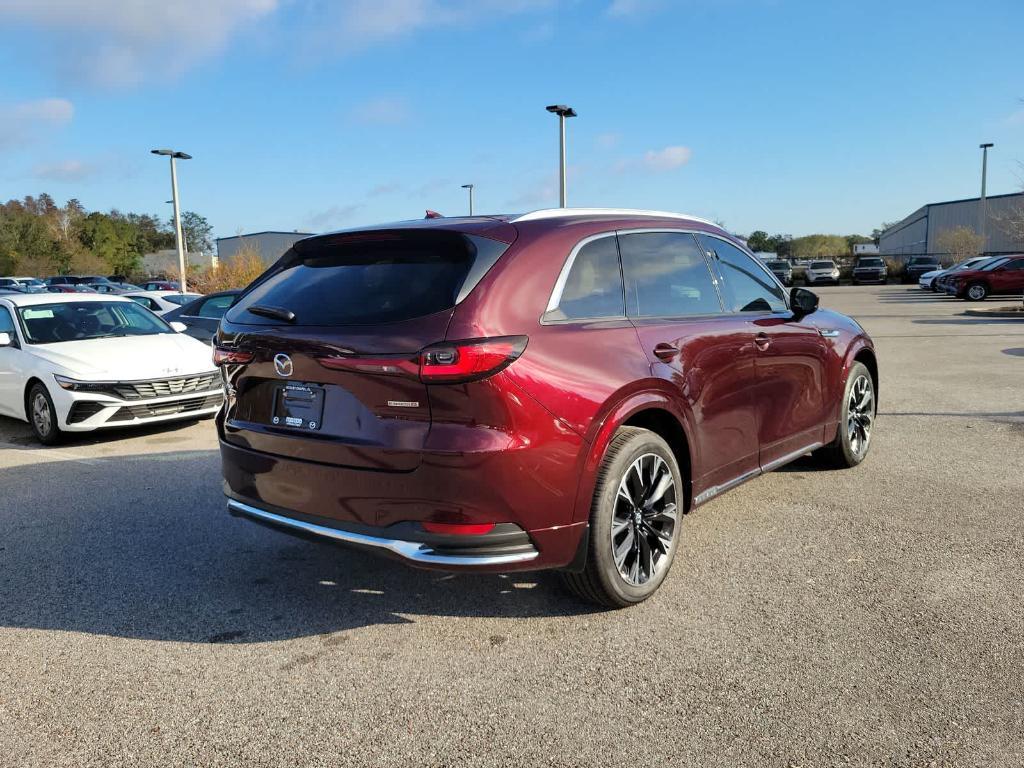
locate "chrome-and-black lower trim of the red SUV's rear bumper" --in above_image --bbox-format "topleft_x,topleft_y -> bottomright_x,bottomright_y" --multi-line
227,499 -> 540,570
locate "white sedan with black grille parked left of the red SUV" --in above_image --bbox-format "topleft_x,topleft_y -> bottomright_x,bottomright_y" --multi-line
0,294 -> 223,445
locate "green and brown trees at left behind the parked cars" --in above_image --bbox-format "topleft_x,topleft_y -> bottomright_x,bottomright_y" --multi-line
0,193 -> 213,276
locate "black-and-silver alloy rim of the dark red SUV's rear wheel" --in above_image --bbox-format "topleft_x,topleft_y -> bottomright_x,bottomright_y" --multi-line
611,454 -> 678,586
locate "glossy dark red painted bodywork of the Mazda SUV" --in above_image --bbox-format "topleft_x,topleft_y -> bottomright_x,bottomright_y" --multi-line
218,210 -> 873,569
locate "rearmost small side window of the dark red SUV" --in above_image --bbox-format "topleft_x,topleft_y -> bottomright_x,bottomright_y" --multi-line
548,234 -> 626,319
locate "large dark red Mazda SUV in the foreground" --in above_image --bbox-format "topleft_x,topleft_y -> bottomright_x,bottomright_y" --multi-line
215,209 -> 878,606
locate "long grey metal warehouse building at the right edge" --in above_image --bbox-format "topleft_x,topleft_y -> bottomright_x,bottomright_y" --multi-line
879,193 -> 1024,256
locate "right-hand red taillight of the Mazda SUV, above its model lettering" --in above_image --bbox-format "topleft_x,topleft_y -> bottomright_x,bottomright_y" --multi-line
317,336 -> 527,384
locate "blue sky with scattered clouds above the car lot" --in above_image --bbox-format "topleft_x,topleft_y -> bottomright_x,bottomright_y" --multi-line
0,0 -> 1024,243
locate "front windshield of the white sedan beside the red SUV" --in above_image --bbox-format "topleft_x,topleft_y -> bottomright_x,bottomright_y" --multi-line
17,301 -> 174,344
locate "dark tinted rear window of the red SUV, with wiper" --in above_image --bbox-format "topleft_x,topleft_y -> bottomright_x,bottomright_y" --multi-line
227,230 -> 508,326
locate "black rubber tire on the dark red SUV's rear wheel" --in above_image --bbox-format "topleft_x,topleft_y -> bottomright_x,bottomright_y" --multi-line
563,427 -> 686,608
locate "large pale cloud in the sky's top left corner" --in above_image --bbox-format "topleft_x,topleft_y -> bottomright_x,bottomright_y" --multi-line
0,0 -> 278,86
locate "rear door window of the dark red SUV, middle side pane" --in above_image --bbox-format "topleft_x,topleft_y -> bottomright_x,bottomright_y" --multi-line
618,232 -> 722,317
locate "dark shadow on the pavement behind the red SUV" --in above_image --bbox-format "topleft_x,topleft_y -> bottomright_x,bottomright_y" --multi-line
0,451 -> 594,643
